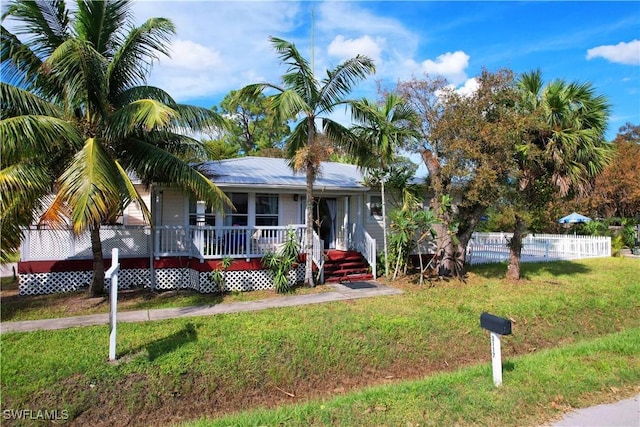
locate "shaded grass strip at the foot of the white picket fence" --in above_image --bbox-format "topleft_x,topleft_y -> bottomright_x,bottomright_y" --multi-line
467,261 -> 591,279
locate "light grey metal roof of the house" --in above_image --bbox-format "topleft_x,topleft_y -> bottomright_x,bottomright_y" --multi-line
198,157 -> 369,191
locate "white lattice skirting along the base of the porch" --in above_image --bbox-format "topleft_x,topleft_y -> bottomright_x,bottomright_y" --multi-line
19,264 -> 304,295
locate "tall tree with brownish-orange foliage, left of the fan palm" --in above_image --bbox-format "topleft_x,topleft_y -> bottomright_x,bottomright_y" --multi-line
397,70 -> 521,277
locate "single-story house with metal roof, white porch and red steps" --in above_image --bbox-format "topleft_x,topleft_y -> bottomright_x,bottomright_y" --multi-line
18,157 -> 400,295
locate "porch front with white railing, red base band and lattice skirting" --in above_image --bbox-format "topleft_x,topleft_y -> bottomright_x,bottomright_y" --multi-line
18,224 -> 376,295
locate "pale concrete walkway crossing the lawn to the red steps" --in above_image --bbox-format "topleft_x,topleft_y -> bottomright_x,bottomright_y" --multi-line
0,281 -> 402,333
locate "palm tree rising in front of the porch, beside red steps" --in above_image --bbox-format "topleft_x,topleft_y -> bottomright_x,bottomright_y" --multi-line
237,37 -> 375,286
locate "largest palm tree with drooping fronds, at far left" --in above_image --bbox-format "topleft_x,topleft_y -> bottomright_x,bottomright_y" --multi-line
0,0 -> 229,295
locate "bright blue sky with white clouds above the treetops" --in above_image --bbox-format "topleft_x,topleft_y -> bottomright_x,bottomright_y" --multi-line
134,1 -> 640,139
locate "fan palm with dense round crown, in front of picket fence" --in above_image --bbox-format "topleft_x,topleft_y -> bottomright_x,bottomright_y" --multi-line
507,70 -> 612,280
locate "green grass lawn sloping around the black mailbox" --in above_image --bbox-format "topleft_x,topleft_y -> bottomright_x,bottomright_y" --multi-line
0,258 -> 640,425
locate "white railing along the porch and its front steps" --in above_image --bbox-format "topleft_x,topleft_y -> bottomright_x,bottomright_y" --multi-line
21,224 -> 376,280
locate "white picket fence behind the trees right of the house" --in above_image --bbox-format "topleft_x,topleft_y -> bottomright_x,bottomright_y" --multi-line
466,233 -> 611,264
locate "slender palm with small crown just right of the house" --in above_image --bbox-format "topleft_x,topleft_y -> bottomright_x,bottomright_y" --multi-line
351,93 -> 417,278
